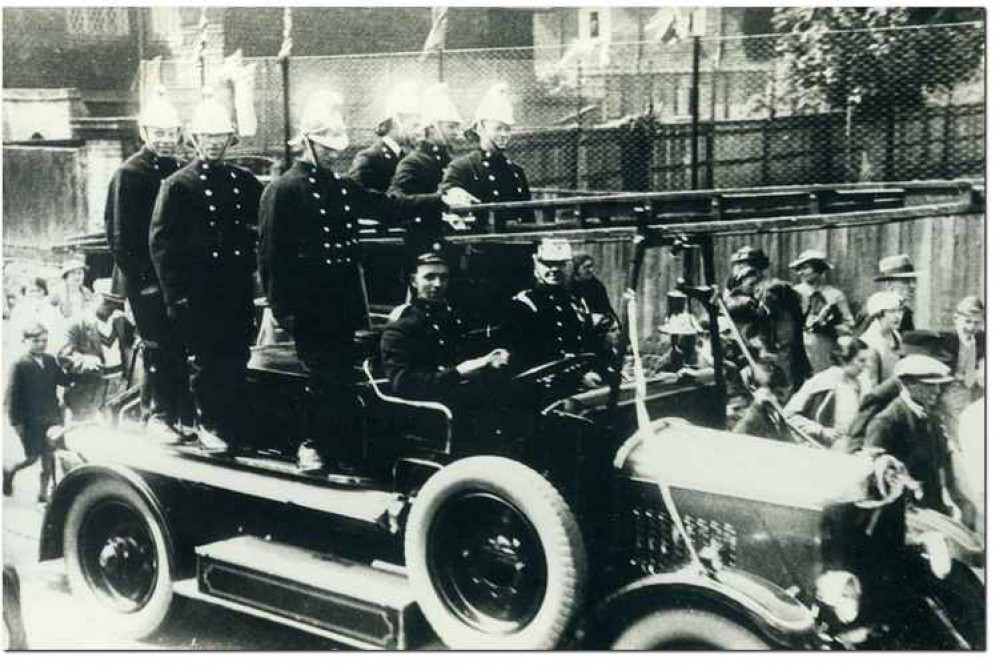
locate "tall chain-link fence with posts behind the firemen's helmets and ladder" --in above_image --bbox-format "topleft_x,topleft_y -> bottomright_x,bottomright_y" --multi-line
142,22 -> 985,191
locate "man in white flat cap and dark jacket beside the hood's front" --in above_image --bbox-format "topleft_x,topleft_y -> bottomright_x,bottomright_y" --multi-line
864,354 -> 969,515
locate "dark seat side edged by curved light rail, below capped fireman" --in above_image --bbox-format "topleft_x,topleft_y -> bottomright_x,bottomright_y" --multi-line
362,358 -> 454,456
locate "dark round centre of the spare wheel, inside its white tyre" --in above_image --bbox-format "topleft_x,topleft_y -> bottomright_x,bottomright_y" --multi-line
427,492 -> 548,633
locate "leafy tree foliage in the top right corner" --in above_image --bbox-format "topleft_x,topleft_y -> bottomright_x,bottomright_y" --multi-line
773,7 -> 985,115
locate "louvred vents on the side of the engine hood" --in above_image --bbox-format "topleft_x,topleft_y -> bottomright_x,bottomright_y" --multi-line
630,507 -> 739,574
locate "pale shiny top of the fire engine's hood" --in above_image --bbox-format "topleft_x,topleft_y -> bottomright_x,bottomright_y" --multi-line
615,418 -> 874,510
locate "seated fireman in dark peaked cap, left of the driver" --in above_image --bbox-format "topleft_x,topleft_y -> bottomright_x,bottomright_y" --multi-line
381,241 -> 510,403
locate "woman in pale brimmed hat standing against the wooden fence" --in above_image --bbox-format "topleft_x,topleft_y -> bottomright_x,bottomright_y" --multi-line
789,250 -> 854,374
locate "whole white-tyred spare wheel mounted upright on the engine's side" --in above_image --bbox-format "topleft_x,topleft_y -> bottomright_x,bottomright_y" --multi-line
406,456 -> 586,649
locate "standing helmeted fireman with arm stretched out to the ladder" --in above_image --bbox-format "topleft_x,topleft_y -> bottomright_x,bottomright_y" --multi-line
258,91 -> 464,472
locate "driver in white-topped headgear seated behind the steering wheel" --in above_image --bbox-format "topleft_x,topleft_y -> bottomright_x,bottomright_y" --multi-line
506,238 -> 609,386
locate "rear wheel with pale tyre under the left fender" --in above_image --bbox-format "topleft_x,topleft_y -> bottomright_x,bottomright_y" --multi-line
63,479 -> 175,640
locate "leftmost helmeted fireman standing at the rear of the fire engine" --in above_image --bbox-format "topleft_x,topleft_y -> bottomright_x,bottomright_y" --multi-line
104,89 -> 190,443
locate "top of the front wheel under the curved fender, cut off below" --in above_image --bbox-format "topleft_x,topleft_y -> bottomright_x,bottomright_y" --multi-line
611,608 -> 769,650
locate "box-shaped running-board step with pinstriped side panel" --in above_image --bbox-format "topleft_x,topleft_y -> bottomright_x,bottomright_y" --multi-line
192,536 -> 429,650
